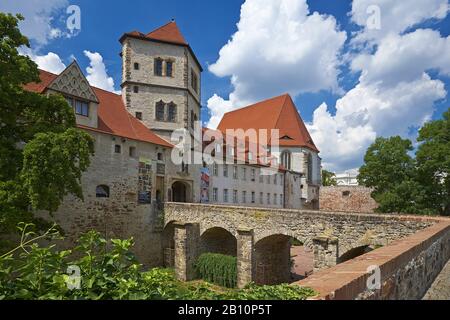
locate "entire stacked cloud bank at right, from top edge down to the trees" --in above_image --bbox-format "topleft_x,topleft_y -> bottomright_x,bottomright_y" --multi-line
307,0 -> 450,171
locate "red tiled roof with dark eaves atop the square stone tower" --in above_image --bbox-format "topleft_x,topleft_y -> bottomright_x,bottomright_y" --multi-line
119,20 -> 203,71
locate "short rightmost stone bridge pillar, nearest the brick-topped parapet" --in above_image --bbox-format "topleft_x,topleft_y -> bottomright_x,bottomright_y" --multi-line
313,237 -> 339,271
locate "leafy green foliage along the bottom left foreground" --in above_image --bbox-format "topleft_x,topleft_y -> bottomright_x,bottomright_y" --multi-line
0,228 -> 314,300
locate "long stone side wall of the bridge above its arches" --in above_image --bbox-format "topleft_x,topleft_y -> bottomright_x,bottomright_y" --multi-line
164,203 -> 434,256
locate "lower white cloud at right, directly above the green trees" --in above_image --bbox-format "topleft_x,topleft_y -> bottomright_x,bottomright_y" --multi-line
307,74 -> 446,171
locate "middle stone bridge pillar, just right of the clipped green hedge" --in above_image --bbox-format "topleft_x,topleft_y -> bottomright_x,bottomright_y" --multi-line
237,228 -> 254,288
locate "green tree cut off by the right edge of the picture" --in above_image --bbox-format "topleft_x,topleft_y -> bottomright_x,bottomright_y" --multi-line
416,108 -> 450,216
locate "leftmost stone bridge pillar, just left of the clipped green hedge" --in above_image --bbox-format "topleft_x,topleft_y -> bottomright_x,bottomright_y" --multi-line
174,223 -> 200,281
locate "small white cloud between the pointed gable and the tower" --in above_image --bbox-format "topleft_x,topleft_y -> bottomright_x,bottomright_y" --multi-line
84,50 -> 118,93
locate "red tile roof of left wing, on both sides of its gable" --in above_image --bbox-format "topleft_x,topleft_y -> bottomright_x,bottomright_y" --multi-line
25,70 -> 173,148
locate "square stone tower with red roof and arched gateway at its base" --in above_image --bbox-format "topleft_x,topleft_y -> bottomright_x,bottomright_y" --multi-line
120,21 -> 203,202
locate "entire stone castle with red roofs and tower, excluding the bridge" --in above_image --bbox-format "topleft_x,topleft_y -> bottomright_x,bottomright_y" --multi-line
26,21 -> 321,266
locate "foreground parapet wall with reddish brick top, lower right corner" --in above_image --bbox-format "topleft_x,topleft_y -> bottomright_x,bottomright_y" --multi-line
297,219 -> 450,300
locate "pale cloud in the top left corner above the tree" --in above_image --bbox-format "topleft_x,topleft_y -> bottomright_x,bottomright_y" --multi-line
0,0 -> 69,45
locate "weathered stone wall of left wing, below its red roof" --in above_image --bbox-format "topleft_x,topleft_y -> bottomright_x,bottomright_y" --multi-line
39,131 -> 168,266
